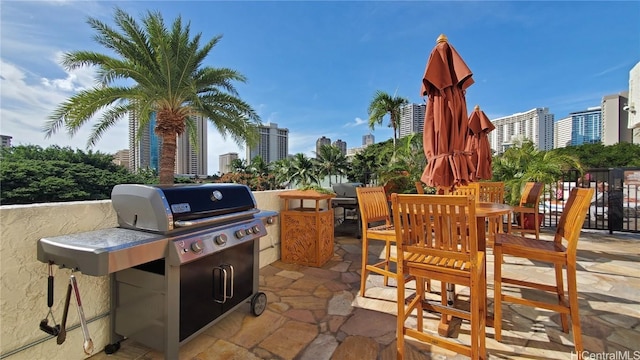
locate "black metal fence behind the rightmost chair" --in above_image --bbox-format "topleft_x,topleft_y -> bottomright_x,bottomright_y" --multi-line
540,168 -> 640,233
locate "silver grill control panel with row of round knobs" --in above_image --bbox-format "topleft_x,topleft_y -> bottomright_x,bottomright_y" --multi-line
168,218 -> 267,265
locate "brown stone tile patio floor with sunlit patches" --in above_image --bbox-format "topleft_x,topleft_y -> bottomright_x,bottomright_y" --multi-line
91,225 -> 640,360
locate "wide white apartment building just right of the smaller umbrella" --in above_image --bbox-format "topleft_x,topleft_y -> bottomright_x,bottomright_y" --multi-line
489,107 -> 553,154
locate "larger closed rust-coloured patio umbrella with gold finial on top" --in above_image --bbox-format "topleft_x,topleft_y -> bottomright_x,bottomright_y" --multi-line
421,35 -> 475,189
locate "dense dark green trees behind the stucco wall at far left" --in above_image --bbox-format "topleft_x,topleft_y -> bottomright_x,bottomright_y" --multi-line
0,145 -> 148,205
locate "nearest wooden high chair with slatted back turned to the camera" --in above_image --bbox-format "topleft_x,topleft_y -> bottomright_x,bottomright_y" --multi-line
391,194 -> 487,359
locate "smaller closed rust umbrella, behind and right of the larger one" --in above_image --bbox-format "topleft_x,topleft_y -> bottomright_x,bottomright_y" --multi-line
465,105 -> 496,180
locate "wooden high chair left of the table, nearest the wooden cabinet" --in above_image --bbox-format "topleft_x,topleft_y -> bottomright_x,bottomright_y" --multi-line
356,186 -> 420,297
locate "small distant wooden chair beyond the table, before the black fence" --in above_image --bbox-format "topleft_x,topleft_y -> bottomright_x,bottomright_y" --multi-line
508,182 -> 544,240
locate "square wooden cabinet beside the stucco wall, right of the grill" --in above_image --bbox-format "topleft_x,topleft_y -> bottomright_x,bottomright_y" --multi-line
280,190 -> 335,267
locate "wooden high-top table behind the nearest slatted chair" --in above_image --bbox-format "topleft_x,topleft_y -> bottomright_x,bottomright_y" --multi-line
438,202 -> 513,336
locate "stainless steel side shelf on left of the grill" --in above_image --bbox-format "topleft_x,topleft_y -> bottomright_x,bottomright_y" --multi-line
37,228 -> 168,276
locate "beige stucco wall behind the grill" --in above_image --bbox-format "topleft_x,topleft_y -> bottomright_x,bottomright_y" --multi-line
0,191 -> 281,360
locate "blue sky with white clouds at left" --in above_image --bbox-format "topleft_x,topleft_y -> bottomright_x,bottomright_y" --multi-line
0,0 -> 640,174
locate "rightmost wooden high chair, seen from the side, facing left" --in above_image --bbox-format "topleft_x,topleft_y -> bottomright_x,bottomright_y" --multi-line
493,188 -> 594,357
